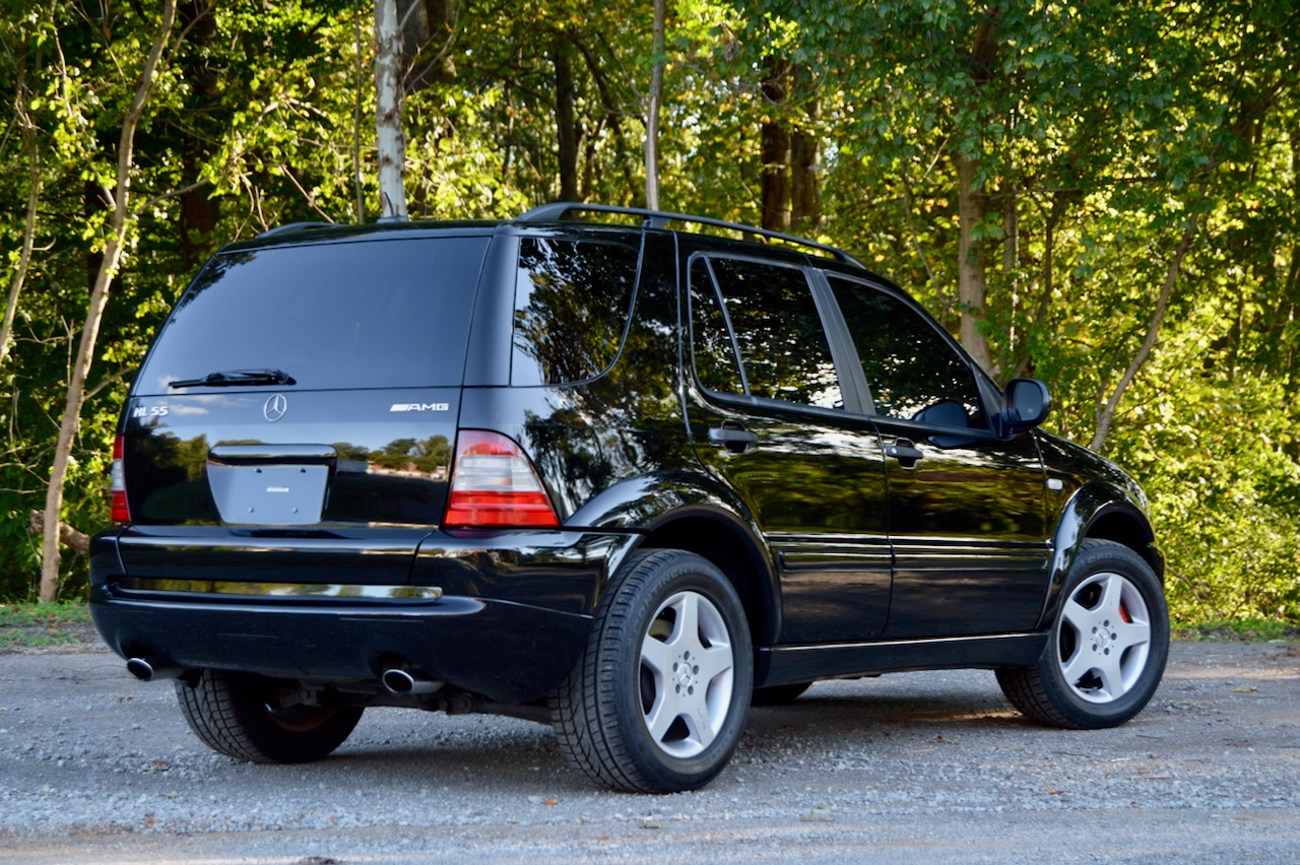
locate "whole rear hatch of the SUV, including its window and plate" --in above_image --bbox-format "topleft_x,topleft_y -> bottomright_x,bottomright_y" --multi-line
120,229 -> 491,592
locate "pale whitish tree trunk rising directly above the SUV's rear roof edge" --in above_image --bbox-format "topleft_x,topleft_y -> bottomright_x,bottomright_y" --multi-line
374,0 -> 407,220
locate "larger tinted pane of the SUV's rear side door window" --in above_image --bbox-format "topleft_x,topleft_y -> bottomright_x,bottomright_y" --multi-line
709,259 -> 844,408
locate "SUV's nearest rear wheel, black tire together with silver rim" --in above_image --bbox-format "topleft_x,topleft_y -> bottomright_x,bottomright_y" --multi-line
551,550 -> 754,793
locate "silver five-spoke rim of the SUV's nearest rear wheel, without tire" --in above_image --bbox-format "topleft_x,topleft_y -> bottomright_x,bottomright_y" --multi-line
640,592 -> 736,758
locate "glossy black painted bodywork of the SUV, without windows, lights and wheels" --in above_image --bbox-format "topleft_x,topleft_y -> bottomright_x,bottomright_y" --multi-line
91,214 -> 1160,704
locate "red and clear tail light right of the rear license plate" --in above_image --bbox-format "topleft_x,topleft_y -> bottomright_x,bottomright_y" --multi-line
443,429 -> 560,528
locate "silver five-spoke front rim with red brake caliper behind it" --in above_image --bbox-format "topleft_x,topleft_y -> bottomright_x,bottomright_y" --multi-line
1057,571 -> 1152,704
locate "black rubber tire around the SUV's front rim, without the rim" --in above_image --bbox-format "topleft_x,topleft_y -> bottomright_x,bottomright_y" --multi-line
1040,542 -> 1169,728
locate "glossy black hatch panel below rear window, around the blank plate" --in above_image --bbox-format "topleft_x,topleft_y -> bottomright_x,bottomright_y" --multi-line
124,388 -> 460,526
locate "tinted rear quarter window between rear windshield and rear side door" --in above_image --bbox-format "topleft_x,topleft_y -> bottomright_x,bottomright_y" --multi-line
511,238 -> 638,385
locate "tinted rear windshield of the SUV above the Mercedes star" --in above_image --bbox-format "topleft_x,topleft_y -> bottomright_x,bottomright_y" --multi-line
137,237 -> 490,393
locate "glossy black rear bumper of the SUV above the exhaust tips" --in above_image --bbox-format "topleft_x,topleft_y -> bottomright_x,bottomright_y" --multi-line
91,527 -> 632,704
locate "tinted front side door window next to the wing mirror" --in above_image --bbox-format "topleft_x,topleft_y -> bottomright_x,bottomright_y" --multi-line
831,277 -> 987,427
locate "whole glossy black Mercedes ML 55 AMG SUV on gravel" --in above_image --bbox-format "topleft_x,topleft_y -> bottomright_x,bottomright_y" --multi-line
91,204 -> 1169,792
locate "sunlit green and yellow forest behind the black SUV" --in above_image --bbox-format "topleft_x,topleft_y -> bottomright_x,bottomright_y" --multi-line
0,0 -> 1300,624
